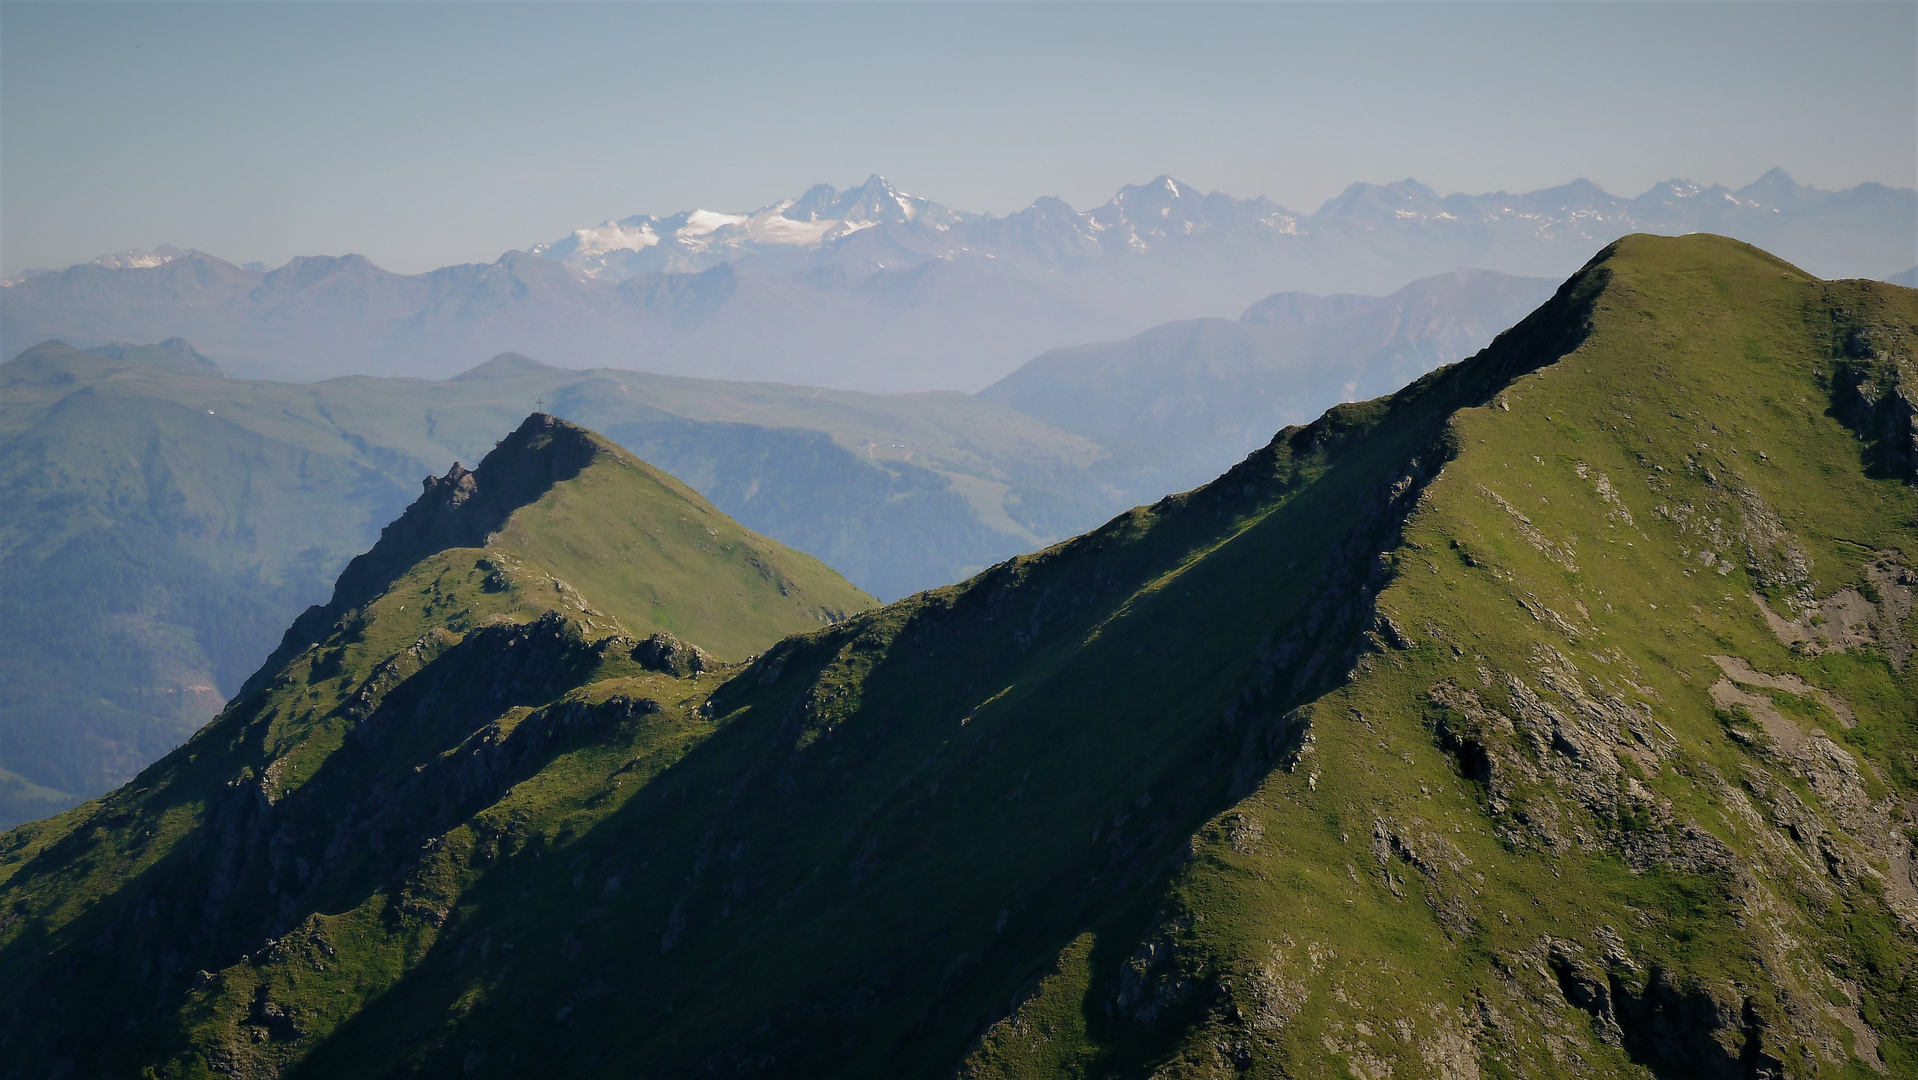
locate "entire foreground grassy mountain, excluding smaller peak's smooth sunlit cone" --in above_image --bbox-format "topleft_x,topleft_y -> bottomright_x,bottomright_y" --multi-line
0,236 -> 1918,1078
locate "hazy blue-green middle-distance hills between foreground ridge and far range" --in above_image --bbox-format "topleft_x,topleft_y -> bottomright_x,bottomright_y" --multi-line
0,265 -> 1542,825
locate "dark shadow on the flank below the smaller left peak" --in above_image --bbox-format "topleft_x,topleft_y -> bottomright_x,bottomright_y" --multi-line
0,616 -> 632,1074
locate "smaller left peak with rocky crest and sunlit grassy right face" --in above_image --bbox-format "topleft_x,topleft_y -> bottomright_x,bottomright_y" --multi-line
0,418 -> 871,1072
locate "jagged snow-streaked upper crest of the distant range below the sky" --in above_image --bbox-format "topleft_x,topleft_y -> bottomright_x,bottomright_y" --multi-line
506,169 -> 1902,282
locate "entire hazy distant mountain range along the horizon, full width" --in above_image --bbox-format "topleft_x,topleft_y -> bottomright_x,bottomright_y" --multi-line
0,169 -> 1918,391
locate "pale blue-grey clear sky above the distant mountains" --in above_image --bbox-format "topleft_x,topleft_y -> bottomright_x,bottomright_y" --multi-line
0,0 -> 1918,276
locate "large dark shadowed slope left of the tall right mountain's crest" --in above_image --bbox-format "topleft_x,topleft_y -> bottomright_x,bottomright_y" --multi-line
283,257 -> 1596,1076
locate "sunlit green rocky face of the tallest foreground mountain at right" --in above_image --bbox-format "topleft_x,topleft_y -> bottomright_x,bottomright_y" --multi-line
969,238 -> 1918,1076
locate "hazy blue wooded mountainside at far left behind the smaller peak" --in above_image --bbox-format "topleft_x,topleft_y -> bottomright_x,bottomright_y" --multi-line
0,349 -> 424,821
